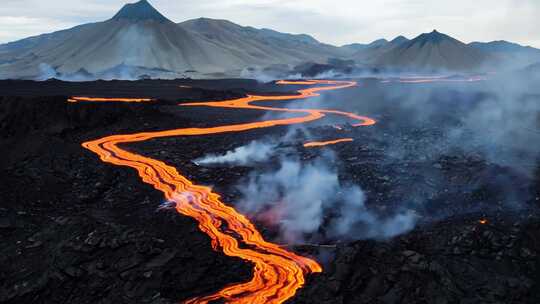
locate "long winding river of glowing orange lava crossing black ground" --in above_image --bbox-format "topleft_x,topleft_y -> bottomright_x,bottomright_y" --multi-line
78,80 -> 376,304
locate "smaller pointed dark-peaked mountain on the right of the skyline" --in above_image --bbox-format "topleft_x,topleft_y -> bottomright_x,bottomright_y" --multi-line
376,31 -> 490,71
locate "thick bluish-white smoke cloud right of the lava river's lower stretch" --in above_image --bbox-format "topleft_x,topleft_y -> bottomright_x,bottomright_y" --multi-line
234,154 -> 416,243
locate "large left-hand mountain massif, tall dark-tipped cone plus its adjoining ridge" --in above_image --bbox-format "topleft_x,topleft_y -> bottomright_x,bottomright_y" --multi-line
0,0 -> 339,78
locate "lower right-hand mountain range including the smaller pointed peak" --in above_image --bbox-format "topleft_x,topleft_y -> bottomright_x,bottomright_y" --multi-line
343,30 -> 540,71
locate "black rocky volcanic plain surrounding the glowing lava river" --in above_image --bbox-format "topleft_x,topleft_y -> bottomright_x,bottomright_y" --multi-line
0,79 -> 540,304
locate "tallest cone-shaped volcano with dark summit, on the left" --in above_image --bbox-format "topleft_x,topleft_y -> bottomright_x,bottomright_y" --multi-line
0,0 -> 229,78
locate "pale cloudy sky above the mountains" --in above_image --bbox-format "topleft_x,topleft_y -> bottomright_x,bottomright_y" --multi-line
0,0 -> 540,48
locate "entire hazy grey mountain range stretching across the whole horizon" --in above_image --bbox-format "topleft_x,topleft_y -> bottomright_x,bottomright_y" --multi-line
0,0 -> 540,79
